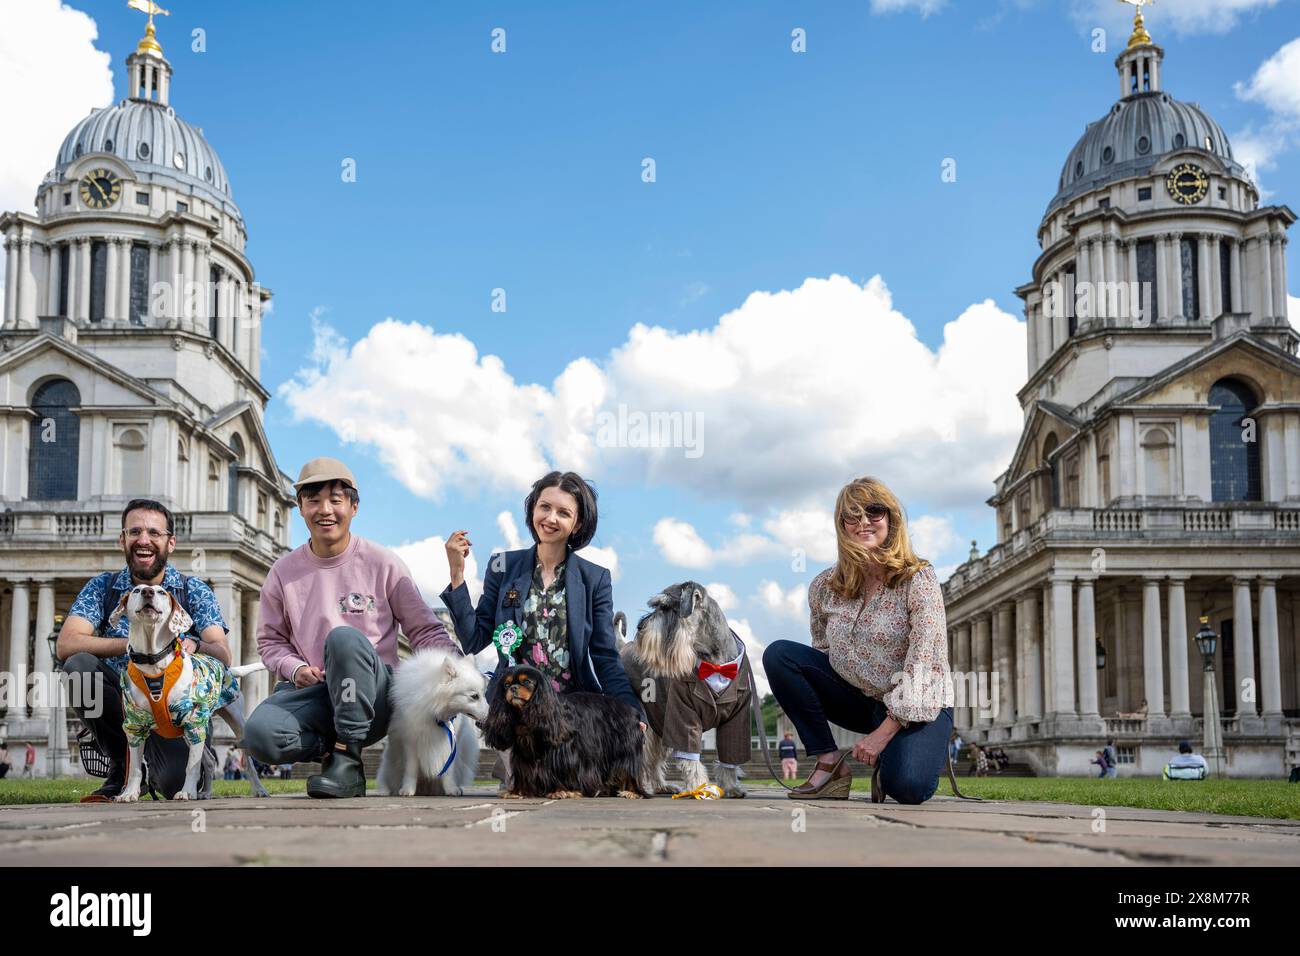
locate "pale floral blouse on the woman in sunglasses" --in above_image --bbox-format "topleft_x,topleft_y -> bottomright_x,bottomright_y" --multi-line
809,564 -> 953,723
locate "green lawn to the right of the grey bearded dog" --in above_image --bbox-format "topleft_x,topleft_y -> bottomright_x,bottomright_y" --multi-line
745,774 -> 1300,819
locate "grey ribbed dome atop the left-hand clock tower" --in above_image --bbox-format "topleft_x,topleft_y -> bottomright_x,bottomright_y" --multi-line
55,99 -> 242,219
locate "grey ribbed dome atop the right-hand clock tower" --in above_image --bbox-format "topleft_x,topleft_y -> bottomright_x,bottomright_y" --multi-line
1048,91 -> 1245,213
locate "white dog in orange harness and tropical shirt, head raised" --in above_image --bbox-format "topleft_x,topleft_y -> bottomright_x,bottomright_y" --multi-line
108,584 -> 268,803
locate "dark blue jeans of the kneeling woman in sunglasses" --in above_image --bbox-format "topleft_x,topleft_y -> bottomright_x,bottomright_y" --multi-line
763,641 -> 953,804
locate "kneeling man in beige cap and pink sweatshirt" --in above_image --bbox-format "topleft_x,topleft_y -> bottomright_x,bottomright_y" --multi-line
244,458 -> 459,797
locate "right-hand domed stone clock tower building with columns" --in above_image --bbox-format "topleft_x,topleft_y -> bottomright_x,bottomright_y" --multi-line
944,10 -> 1300,777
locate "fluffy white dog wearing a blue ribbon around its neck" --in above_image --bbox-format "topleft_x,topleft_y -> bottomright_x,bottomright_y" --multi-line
374,648 -> 488,796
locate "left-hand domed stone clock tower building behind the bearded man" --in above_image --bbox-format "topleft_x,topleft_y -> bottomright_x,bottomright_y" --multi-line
0,18 -> 294,775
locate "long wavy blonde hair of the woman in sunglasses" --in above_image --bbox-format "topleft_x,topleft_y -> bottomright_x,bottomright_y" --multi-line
828,475 -> 930,600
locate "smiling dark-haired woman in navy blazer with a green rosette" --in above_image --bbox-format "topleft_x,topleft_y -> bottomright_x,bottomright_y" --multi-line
441,471 -> 645,724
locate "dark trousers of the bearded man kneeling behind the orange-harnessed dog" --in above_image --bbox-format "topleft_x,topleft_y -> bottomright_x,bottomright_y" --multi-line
64,650 -> 217,800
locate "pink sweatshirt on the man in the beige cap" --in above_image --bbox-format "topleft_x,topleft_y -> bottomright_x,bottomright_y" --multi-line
257,535 -> 459,680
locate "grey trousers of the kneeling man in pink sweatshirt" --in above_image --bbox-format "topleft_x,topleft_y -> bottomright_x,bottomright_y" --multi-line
244,627 -> 393,765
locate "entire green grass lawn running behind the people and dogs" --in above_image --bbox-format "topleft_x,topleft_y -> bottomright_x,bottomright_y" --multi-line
0,774 -> 1300,819
